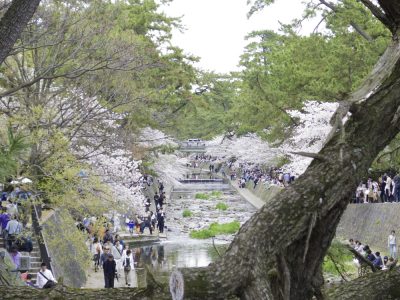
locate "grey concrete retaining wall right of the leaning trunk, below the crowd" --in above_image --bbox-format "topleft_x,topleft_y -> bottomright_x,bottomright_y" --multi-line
336,203 -> 400,252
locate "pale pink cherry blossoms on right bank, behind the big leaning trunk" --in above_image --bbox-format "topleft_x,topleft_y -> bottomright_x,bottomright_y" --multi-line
207,101 -> 338,175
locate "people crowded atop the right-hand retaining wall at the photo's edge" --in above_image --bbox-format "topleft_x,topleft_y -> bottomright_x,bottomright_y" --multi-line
352,173 -> 400,203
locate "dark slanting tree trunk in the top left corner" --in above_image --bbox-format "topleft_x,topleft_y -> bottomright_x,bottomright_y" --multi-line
0,0 -> 40,65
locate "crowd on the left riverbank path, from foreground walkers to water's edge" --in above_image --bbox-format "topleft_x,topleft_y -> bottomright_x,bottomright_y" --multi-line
77,181 -> 166,288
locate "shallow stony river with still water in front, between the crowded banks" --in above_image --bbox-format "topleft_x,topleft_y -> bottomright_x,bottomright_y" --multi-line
86,159 -> 256,288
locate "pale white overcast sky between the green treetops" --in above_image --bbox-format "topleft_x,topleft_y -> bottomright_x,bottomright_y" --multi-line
163,0 -> 312,73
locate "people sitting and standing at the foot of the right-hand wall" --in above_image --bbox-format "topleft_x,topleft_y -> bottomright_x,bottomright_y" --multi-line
349,230 -> 397,270
